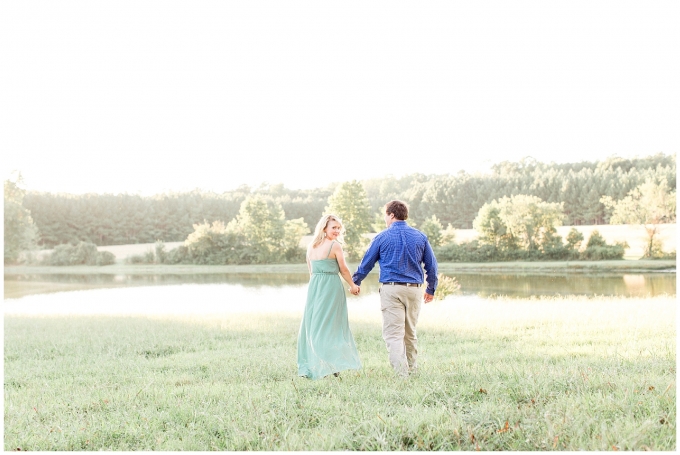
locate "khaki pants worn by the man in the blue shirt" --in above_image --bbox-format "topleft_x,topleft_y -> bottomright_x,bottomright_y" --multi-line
380,285 -> 423,377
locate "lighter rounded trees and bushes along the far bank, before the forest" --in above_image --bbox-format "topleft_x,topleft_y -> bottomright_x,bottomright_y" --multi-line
128,174 -> 676,265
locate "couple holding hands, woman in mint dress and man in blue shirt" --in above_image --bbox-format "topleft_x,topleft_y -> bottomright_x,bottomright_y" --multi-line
297,201 -> 437,379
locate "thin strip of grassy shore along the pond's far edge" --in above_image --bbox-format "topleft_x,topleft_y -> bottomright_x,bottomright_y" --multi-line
4,259 -> 677,275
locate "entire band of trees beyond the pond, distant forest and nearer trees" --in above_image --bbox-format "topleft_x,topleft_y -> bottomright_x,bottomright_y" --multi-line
5,154 -> 676,264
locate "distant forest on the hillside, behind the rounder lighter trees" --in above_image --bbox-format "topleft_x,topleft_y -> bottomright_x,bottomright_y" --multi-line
23,154 -> 676,248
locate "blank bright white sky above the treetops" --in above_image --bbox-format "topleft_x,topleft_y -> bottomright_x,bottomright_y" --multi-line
0,0 -> 680,194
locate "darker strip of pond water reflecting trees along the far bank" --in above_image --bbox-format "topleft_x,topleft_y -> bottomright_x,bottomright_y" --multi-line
4,273 -> 676,299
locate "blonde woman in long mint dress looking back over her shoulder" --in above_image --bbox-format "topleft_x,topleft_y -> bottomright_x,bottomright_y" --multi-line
298,215 -> 361,379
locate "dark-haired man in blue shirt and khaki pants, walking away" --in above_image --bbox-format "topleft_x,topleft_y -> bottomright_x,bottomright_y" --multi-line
352,201 -> 437,377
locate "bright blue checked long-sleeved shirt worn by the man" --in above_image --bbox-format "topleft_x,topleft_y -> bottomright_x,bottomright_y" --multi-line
352,221 -> 438,295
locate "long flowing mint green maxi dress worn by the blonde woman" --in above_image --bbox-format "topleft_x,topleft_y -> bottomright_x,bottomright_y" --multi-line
298,244 -> 361,379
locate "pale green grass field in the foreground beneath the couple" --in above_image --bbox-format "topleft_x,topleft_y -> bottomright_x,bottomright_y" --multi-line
4,296 -> 676,451
